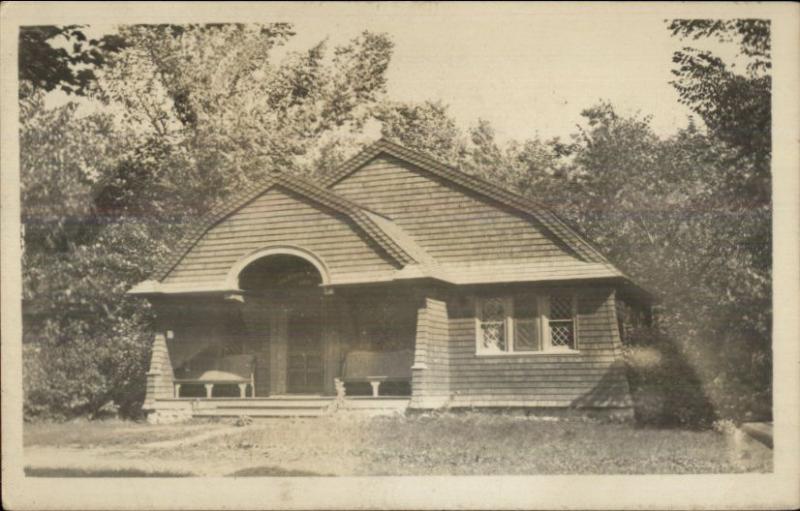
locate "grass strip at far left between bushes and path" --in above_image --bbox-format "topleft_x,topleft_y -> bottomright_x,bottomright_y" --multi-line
22,419 -> 225,447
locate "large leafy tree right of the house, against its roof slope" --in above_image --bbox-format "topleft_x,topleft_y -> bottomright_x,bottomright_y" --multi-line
542,104 -> 770,418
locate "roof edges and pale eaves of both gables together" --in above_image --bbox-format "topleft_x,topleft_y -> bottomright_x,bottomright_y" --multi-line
130,139 -> 653,297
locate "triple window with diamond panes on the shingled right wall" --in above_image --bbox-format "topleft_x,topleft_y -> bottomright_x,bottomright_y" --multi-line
475,293 -> 577,355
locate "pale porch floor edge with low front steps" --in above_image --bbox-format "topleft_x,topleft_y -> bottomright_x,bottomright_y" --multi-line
154,395 -> 411,417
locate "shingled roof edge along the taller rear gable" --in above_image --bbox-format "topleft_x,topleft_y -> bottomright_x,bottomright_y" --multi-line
322,139 -> 618,271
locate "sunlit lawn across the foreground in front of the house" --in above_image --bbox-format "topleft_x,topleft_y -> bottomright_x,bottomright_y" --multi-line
21,413 -> 772,477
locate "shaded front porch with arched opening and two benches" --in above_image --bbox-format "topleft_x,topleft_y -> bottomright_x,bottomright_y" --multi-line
139,249 -> 438,417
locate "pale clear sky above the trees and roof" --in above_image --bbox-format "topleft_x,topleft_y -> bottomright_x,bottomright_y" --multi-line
50,3 -> 752,144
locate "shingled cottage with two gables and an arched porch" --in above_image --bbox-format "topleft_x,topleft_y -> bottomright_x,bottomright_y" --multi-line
130,140 -> 650,418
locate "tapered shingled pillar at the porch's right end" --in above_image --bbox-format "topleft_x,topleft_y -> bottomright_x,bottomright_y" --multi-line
411,297 -> 450,408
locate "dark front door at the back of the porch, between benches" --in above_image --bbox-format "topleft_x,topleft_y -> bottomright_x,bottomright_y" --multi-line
286,307 -> 323,394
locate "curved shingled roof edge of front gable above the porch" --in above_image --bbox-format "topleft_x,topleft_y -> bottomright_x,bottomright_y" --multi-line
152,172 -> 421,281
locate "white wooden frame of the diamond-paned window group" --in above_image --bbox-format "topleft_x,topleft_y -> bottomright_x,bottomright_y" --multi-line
474,290 -> 580,357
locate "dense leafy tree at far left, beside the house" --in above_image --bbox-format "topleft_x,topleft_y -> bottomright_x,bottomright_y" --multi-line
20,92 -> 163,417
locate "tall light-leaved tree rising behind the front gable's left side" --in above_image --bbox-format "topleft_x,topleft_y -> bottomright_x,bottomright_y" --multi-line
101,23 -> 392,210
